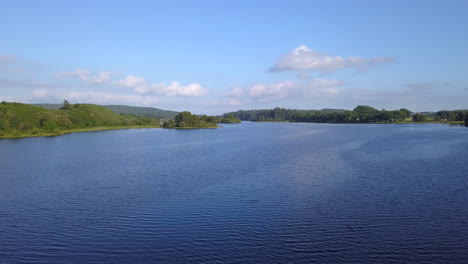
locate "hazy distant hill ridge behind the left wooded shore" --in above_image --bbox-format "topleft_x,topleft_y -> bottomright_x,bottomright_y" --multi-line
33,104 -> 178,119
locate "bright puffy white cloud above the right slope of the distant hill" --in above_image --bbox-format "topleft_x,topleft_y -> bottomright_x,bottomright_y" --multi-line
117,75 -> 208,96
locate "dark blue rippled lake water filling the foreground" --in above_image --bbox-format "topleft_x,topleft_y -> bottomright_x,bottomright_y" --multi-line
0,123 -> 468,263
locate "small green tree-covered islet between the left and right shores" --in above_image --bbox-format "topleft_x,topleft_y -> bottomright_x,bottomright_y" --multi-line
163,111 -> 219,128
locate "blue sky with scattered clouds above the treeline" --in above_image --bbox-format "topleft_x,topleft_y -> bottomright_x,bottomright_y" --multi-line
0,0 -> 468,114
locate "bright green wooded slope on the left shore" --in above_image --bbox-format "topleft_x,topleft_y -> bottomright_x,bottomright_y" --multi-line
0,101 -> 159,137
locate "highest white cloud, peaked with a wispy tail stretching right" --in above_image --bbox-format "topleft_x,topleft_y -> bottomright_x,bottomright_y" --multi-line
270,45 -> 394,72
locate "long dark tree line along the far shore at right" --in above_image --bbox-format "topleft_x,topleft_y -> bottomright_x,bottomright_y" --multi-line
225,105 -> 468,123
